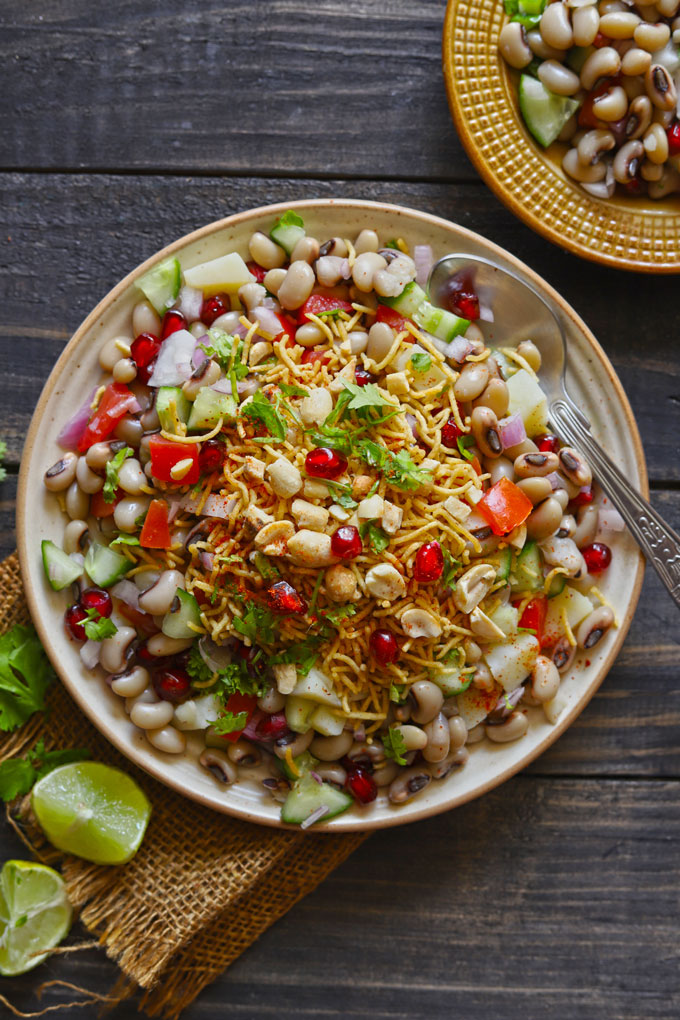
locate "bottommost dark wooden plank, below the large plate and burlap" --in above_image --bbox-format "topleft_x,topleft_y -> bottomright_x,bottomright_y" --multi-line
3,776 -> 680,1020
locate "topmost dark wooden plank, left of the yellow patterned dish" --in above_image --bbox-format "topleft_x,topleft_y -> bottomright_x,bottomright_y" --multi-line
0,0 -> 474,180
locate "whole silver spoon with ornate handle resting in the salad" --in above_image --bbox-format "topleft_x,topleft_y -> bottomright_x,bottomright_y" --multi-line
428,253 -> 680,607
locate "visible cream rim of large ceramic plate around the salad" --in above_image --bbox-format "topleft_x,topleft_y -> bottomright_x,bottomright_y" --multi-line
17,199 -> 646,832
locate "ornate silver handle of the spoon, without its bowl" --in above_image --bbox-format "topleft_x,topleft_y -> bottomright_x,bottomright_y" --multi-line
551,398 -> 680,607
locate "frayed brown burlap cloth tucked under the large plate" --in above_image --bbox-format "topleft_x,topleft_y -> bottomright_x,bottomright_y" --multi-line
0,555 -> 366,1020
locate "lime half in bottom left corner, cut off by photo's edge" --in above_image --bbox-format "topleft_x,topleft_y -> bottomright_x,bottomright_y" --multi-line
0,861 -> 72,977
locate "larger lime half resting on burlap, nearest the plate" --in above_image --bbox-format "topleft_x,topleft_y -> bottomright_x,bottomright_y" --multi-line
31,762 -> 151,864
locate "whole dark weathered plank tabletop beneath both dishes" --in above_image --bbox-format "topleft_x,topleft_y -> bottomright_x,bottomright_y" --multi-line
0,0 -> 680,1020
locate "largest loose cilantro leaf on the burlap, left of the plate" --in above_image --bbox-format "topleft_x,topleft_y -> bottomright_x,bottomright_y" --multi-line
0,623 -> 54,730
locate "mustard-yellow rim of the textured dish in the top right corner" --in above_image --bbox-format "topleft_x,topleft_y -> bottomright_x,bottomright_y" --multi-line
443,0 -> 680,272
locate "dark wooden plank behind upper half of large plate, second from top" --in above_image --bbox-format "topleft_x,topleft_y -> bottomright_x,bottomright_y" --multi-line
0,174 -> 680,481
